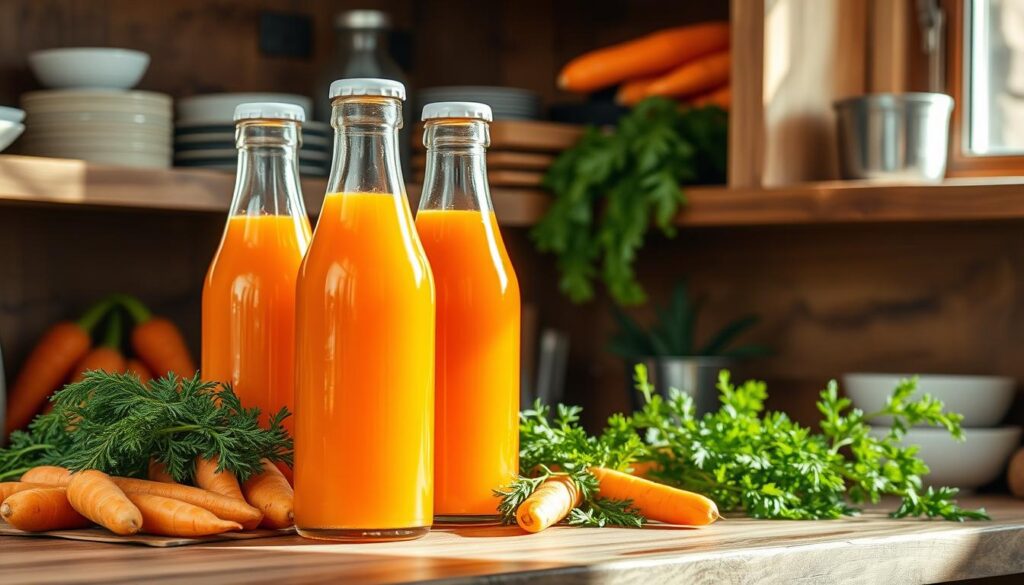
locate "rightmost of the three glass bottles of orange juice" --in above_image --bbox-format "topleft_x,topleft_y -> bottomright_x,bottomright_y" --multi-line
416,101 -> 520,523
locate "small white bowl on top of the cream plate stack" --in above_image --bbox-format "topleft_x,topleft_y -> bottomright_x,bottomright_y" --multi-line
29,47 -> 150,89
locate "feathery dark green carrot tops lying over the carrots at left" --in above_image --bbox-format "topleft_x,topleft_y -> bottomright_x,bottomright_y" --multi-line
0,372 -> 292,483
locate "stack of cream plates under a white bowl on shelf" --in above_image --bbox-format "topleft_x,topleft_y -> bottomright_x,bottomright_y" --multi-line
18,89 -> 173,167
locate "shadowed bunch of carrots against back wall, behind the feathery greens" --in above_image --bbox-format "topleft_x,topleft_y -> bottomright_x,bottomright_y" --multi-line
3,295 -> 196,436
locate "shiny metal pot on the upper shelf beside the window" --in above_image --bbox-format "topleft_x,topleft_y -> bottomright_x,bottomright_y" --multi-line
835,93 -> 953,182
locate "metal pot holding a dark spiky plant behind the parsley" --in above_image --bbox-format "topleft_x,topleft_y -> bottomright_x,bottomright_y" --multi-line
630,357 -> 736,416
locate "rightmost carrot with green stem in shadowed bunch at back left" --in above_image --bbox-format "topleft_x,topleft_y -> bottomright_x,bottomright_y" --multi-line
117,295 -> 196,378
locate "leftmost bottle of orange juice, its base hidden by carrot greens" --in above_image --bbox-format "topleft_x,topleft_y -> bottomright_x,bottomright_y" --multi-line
202,102 -> 310,483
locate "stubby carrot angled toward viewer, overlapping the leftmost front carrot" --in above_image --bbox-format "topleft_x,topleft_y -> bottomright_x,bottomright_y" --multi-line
68,469 -> 142,536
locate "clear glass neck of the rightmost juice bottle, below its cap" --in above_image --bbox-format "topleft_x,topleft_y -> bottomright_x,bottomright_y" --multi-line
420,119 -> 494,212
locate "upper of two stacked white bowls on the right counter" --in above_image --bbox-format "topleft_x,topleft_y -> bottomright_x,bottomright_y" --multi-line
843,374 -> 1016,427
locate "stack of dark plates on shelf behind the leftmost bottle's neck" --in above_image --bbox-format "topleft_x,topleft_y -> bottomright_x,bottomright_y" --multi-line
174,93 -> 332,176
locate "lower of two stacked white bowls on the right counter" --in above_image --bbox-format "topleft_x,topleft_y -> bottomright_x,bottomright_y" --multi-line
871,426 -> 1021,492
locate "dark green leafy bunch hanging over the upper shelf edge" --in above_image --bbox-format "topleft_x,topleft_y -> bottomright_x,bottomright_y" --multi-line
532,97 -> 727,304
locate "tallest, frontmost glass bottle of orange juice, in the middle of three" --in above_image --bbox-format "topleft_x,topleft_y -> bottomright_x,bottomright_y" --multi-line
295,79 -> 434,541
